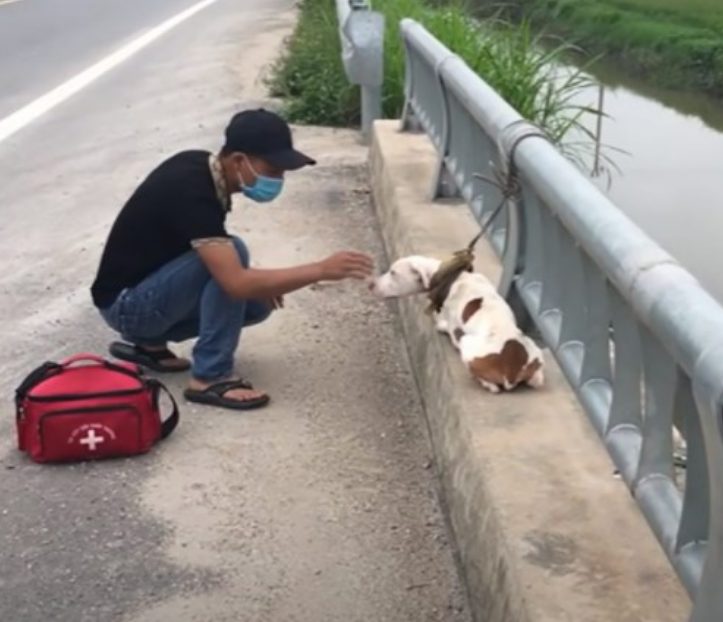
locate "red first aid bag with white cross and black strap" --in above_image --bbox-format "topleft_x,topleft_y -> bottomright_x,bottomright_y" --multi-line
15,354 -> 179,462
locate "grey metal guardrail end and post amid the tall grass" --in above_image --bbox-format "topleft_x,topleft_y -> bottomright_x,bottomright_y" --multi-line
336,0 -> 384,140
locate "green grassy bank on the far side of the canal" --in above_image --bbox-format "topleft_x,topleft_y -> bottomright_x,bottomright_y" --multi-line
506,0 -> 723,96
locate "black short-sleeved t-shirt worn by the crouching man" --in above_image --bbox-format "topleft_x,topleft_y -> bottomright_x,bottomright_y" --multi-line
91,151 -> 228,309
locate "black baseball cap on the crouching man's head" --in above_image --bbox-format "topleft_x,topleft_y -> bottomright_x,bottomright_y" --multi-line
224,108 -> 316,171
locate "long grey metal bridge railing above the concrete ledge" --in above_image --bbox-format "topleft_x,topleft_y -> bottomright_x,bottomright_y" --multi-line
401,20 -> 723,622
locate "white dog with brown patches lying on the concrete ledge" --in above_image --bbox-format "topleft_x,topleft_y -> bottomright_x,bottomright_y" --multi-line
371,255 -> 544,393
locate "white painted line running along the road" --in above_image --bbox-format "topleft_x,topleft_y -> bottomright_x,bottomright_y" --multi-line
0,0 -> 217,142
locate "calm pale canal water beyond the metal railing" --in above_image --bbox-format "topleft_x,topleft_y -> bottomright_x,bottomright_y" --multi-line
572,65 -> 723,303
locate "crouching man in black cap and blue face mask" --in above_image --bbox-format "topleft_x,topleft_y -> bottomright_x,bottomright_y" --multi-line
91,110 -> 373,409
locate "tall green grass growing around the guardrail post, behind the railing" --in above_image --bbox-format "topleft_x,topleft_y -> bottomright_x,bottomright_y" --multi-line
270,0 -> 594,150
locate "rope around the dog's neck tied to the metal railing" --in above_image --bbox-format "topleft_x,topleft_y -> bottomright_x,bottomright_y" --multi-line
427,120 -> 549,313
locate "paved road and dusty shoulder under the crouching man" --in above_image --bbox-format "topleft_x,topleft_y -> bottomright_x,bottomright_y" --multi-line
0,0 -> 469,622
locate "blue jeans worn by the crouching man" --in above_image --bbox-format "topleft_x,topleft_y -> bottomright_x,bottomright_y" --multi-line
100,237 -> 271,381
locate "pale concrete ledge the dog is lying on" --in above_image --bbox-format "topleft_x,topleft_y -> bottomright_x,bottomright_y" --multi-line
370,121 -> 690,622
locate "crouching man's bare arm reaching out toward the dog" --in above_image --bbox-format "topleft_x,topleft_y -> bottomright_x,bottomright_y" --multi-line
196,243 -> 373,299
